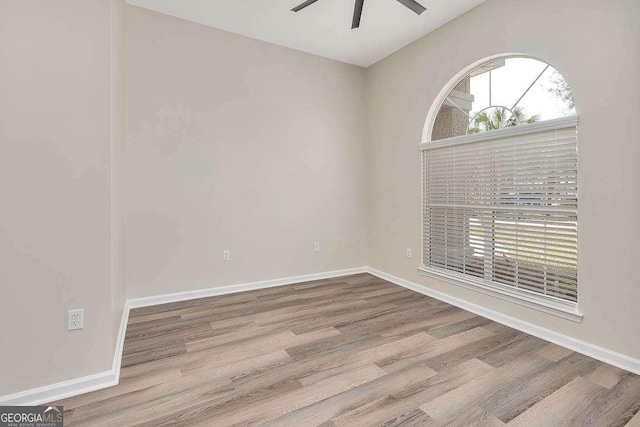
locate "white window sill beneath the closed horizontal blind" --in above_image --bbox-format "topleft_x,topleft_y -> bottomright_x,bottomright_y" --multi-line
418,267 -> 583,323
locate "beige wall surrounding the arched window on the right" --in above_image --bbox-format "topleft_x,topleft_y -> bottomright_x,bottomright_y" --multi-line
367,0 -> 640,358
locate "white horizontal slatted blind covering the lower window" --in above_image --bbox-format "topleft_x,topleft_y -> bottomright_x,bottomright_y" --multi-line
421,117 -> 578,307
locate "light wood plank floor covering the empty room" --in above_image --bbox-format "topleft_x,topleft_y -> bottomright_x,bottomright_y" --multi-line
55,274 -> 640,427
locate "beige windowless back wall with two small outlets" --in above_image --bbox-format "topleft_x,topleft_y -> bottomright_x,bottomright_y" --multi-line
125,6 -> 366,298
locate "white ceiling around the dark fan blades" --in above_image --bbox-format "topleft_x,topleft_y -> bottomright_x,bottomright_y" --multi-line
127,0 -> 485,67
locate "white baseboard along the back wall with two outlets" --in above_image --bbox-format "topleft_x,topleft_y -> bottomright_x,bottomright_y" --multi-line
127,267 -> 367,309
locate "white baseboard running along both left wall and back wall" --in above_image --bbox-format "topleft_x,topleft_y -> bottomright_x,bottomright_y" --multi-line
0,267 -> 367,406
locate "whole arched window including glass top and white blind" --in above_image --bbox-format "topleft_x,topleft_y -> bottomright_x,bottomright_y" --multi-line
420,57 -> 581,320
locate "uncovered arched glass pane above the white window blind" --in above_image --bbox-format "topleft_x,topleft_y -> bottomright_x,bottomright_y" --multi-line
430,56 -> 576,141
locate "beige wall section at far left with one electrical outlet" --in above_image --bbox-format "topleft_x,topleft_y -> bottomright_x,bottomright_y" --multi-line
0,0 -> 123,396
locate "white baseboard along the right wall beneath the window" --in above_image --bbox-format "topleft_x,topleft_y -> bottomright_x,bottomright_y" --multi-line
366,267 -> 640,375
